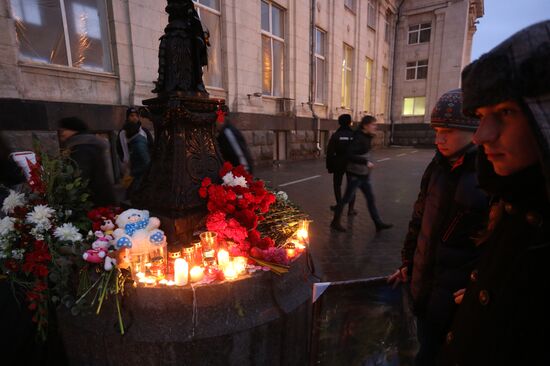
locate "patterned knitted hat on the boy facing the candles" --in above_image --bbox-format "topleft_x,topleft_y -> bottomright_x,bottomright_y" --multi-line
431,89 -> 479,131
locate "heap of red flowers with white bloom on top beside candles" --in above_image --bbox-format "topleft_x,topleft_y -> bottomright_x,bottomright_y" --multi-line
199,162 -> 294,265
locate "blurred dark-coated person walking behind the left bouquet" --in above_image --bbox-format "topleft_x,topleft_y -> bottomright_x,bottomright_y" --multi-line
59,117 -> 116,206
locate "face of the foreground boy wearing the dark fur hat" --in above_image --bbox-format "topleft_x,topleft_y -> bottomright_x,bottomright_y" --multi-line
474,100 -> 538,176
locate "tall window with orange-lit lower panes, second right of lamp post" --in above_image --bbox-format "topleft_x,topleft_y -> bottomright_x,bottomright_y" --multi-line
261,1 -> 285,97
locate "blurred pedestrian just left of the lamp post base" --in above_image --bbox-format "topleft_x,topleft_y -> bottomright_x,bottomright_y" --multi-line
116,107 -> 154,195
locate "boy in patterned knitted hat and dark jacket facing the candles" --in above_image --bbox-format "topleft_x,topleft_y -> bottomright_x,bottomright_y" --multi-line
388,89 -> 489,366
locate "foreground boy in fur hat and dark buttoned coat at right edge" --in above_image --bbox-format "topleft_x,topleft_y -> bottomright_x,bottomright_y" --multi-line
441,21 -> 550,366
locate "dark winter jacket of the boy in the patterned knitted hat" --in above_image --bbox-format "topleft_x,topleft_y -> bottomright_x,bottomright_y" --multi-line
402,145 -> 488,318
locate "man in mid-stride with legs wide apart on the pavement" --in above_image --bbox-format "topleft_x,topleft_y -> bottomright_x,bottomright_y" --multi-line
330,116 -> 393,232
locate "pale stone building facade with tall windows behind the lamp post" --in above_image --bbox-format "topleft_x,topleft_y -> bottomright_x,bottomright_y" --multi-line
0,0 -> 483,167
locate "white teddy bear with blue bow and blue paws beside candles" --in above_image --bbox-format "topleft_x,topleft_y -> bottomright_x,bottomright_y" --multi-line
113,208 -> 166,253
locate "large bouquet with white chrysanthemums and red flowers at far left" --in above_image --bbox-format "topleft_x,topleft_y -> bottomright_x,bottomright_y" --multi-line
0,152 -> 90,339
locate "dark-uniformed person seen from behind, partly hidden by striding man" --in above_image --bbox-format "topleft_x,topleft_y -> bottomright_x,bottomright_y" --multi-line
326,114 -> 357,215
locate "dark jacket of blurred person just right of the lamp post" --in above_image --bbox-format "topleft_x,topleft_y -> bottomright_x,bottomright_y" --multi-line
218,121 -> 254,173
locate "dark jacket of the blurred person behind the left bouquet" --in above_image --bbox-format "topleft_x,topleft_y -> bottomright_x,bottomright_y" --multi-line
65,133 -> 115,206
